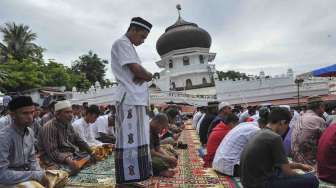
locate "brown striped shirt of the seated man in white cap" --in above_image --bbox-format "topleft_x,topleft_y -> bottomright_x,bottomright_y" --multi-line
39,118 -> 91,163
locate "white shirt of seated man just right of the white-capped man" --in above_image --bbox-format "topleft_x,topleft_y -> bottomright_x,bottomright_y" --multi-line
72,118 -> 102,147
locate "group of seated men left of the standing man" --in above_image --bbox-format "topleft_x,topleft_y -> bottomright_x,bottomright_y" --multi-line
0,96 -> 115,187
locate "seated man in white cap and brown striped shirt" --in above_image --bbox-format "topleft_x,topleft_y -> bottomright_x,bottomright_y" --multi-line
39,100 -> 95,174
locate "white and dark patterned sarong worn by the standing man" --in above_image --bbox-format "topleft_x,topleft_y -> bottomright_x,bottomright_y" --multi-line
115,103 -> 153,184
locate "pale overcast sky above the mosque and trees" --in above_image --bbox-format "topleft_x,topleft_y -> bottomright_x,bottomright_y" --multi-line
0,0 -> 336,78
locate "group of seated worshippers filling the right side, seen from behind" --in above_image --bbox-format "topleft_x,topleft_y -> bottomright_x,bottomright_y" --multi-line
192,96 -> 336,188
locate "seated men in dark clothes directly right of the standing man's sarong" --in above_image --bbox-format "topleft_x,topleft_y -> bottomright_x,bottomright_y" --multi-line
150,106 -> 192,177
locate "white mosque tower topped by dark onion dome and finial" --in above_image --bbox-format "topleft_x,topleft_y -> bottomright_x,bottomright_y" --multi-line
156,5 -> 216,95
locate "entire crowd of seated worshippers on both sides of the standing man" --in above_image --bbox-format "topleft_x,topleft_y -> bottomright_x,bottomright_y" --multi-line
0,96 -> 336,188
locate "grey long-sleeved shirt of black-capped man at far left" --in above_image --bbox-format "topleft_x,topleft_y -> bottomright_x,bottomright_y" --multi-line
0,124 -> 44,185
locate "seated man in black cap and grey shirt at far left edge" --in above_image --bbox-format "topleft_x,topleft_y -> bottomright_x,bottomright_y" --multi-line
0,96 -> 49,187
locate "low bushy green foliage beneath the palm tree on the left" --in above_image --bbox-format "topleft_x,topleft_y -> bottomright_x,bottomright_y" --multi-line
0,58 -> 91,92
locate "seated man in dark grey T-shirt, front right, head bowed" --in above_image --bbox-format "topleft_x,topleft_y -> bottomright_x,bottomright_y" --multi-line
240,107 -> 319,188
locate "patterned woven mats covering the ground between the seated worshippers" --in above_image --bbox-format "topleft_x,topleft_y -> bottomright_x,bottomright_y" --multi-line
66,124 -> 336,188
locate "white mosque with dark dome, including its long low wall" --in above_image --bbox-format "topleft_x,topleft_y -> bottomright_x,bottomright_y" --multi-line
72,5 -> 336,105
